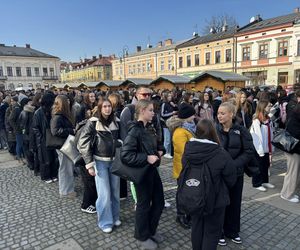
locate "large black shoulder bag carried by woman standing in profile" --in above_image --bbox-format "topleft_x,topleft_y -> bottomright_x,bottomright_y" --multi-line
111,148 -> 149,184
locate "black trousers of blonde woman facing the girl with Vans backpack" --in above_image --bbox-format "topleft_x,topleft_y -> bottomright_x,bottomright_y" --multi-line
223,176 -> 244,238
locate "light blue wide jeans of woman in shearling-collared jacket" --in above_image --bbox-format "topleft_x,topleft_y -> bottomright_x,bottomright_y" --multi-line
95,160 -> 120,230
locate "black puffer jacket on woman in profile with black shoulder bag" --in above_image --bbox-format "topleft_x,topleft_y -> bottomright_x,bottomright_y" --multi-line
121,121 -> 160,167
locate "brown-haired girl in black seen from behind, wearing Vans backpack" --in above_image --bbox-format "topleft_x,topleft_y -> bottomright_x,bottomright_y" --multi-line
182,119 -> 236,250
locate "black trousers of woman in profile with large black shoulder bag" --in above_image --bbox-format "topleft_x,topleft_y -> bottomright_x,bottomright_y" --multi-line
134,167 -> 164,241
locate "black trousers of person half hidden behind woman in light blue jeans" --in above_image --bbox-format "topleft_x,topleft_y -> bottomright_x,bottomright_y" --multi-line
79,165 -> 97,209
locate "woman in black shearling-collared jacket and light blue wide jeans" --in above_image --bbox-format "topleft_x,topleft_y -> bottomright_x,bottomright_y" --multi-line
77,98 -> 121,233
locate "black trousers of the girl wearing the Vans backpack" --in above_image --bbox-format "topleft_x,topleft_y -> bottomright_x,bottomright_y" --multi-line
191,207 -> 226,250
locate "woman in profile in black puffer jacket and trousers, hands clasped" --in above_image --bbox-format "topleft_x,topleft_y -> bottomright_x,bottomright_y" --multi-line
121,100 -> 164,249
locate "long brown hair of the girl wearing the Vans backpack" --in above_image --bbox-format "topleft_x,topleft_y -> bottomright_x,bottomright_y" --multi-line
196,119 -> 220,145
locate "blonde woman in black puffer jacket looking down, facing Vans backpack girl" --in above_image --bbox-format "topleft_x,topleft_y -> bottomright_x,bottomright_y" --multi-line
217,102 -> 254,245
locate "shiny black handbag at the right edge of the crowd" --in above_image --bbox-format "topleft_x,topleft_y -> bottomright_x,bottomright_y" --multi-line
272,129 -> 299,153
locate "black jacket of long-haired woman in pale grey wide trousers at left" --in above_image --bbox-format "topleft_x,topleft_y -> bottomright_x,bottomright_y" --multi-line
50,113 -> 74,139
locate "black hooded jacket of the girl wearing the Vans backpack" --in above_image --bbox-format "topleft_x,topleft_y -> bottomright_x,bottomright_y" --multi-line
182,138 -> 237,208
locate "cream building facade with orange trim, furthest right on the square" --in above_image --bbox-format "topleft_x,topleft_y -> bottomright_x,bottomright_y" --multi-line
235,9 -> 300,86
